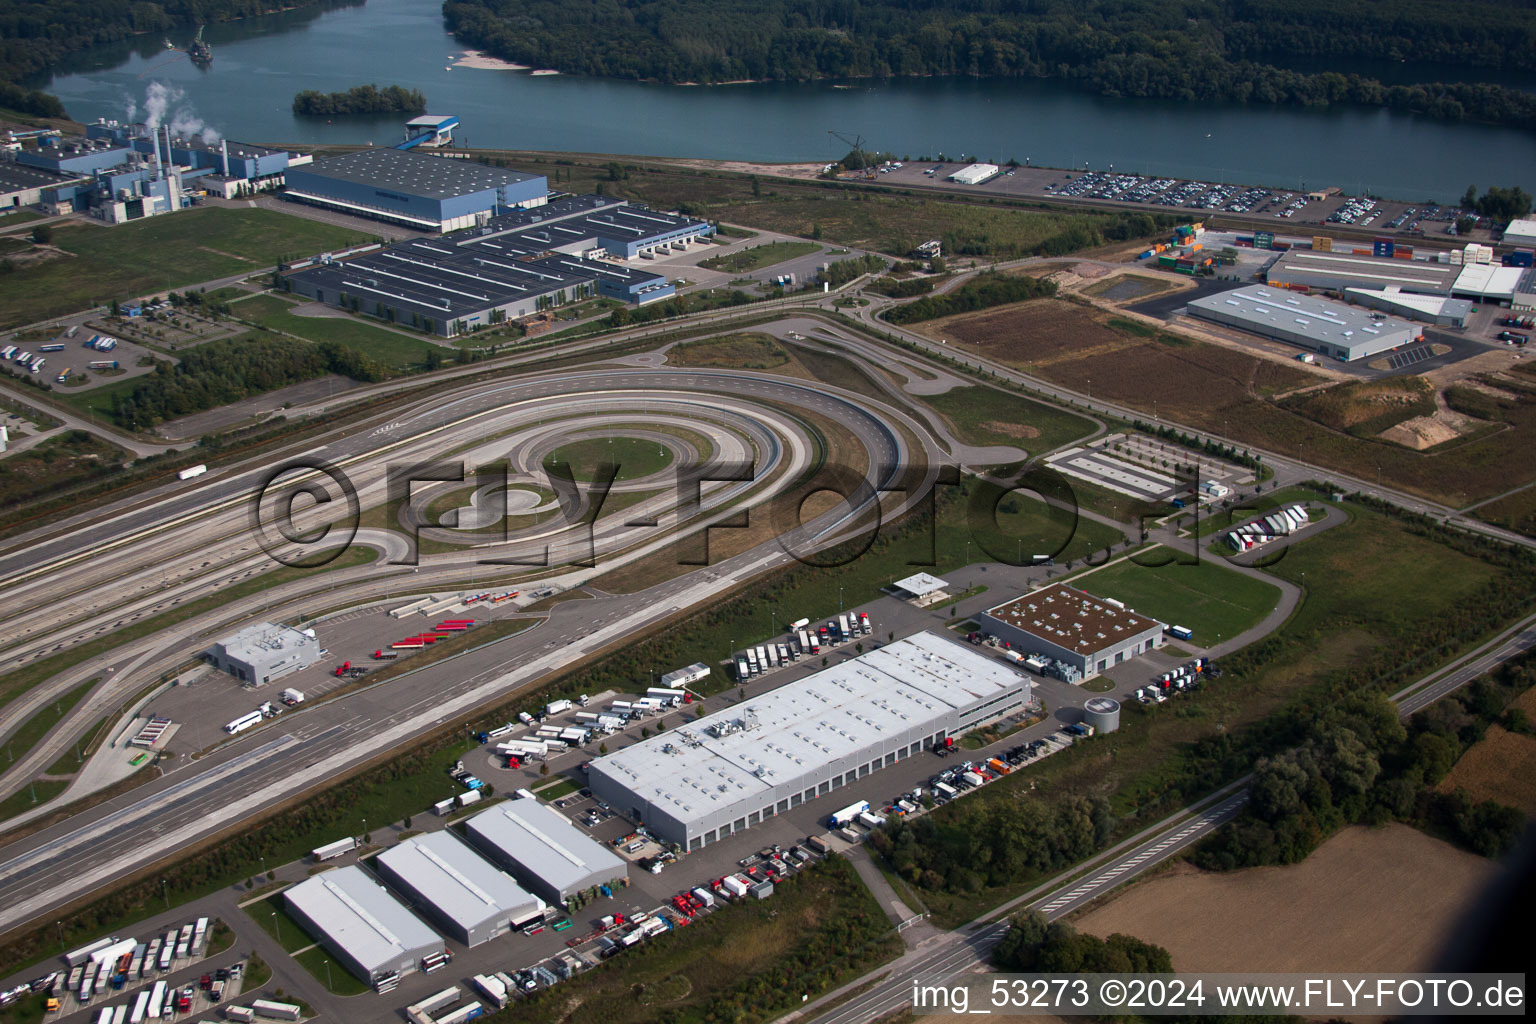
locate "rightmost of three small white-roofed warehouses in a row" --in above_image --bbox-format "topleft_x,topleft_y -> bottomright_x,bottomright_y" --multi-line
464,797 -> 628,906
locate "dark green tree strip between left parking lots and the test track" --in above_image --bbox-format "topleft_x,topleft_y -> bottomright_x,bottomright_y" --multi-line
114,335 -> 384,430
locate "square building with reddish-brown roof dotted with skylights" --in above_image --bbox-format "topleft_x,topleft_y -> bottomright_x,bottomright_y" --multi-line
977,583 -> 1163,683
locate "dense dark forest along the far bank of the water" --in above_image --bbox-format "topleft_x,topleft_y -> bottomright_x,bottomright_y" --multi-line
442,0 -> 1536,126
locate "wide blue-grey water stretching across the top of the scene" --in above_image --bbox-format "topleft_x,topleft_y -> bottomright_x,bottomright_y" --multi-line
32,0 -> 1536,201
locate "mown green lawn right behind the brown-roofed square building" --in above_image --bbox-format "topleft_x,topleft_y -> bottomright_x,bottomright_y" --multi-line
1072,547 -> 1279,646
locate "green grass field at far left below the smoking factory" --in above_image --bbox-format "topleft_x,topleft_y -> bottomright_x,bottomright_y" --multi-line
0,207 -> 369,327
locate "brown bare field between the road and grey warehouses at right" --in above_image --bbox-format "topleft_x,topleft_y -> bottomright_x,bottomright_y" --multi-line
923,299 -> 1536,507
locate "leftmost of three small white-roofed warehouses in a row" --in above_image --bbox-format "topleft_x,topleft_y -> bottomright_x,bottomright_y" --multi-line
283,866 -> 442,986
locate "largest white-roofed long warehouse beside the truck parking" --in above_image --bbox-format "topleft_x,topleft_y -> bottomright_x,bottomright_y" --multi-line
587,633 -> 1031,851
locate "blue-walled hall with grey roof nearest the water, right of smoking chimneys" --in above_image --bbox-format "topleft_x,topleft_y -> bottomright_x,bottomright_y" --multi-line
287,149 -> 550,232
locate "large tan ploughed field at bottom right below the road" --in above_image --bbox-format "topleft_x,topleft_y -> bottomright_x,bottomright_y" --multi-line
1077,824 -> 1499,972
